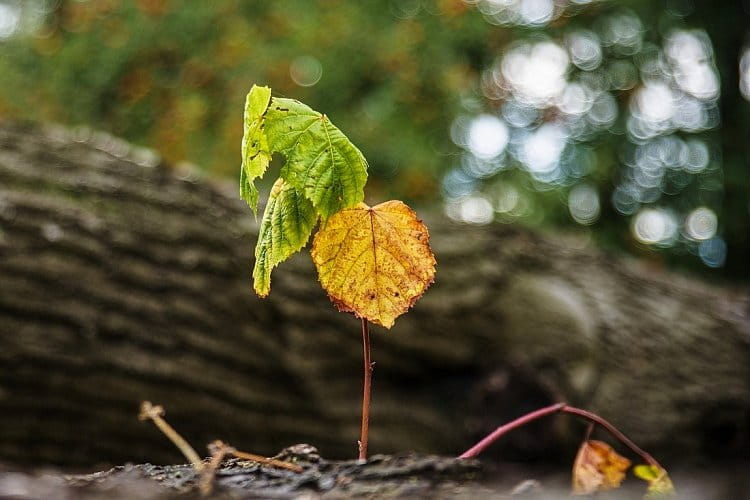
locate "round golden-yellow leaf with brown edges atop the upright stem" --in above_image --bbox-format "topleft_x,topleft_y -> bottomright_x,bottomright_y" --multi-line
310,201 -> 435,328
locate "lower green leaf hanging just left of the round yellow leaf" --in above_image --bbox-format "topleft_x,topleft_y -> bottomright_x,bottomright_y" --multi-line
253,178 -> 318,297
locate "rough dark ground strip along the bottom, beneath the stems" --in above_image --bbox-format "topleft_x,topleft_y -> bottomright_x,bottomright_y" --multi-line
0,445 -> 750,500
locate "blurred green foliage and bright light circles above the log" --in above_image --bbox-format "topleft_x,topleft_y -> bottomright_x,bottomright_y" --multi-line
0,0 -> 750,280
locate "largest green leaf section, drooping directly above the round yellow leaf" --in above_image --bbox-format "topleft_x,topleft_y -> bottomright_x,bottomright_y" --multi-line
265,98 -> 367,219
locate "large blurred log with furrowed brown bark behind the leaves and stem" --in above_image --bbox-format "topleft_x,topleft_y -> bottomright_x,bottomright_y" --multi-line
0,123 -> 750,465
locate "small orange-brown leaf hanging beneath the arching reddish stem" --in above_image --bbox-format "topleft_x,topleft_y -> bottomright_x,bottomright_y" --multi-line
573,440 -> 630,495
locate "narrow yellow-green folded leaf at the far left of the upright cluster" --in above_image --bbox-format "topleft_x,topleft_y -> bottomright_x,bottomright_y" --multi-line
240,85 -> 271,215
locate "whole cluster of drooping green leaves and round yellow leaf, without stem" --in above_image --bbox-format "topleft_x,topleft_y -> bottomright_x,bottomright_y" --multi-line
240,85 -> 435,328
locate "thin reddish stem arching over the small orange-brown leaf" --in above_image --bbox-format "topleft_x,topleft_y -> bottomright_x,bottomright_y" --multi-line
459,403 -> 663,469
